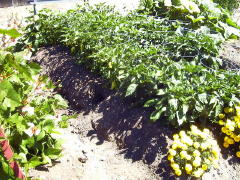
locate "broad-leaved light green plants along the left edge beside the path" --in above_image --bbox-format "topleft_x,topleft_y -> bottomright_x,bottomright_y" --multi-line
0,30 -> 67,179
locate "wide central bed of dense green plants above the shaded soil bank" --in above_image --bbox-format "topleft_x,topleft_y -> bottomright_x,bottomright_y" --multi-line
18,4 -> 239,126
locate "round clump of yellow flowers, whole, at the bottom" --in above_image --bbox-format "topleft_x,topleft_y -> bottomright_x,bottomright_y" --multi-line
168,125 -> 219,177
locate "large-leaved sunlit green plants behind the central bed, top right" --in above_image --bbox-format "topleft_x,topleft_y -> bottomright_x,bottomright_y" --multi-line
139,0 -> 240,39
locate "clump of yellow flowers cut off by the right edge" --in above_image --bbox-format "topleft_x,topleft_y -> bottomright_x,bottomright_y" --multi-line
218,106 -> 240,158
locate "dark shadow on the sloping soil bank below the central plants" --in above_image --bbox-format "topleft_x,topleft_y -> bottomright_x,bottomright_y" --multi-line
32,46 -> 184,179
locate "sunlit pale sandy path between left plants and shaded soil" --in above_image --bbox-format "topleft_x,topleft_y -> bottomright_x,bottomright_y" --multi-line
29,113 -> 159,180
